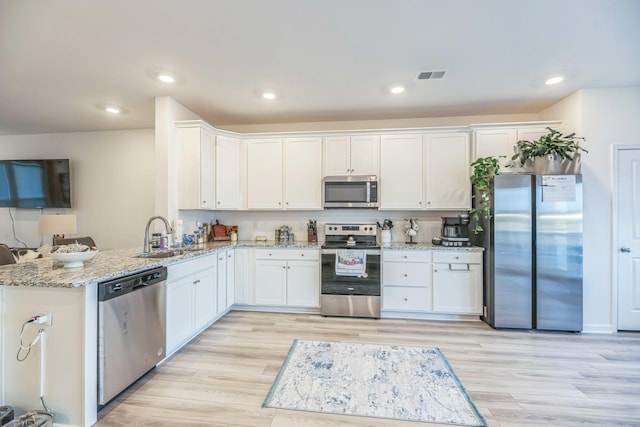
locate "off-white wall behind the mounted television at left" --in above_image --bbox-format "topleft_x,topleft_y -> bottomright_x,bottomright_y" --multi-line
0,129 -> 155,249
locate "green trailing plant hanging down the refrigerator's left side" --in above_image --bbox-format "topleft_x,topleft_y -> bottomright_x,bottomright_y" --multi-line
469,156 -> 500,234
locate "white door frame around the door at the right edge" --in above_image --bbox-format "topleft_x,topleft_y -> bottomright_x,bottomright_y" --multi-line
611,144 -> 640,333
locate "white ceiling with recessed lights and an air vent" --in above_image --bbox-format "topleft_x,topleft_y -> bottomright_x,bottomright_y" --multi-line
0,0 -> 640,134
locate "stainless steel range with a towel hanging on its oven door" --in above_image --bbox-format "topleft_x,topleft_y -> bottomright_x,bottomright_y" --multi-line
320,223 -> 381,318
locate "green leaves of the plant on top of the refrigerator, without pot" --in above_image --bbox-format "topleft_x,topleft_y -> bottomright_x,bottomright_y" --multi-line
509,127 -> 588,166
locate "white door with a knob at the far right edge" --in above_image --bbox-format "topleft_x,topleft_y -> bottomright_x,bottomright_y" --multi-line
616,148 -> 640,331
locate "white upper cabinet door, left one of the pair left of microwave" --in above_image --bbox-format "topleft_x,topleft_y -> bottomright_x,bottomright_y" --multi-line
247,139 -> 283,209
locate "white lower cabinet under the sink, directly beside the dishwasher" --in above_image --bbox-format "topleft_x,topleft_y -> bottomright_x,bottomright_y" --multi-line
167,254 -> 217,355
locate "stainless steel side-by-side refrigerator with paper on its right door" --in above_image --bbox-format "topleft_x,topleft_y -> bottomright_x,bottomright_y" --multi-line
474,174 -> 582,331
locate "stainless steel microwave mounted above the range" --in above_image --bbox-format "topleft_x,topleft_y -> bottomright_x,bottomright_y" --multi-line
322,175 -> 378,209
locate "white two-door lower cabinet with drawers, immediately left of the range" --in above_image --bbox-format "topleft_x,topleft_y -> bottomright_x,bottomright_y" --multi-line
255,249 -> 320,308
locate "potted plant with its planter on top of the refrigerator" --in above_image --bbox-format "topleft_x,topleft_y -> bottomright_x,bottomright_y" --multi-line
509,127 -> 588,175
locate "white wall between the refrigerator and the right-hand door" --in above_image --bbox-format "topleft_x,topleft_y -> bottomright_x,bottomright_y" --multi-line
540,87 -> 640,332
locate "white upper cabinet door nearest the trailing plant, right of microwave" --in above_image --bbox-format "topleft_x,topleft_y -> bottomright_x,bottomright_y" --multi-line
424,132 -> 471,210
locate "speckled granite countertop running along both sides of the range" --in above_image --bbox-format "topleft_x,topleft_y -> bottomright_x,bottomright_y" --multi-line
0,240 -> 484,288
